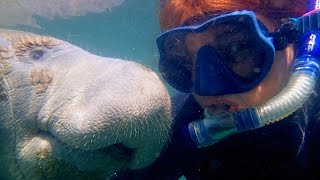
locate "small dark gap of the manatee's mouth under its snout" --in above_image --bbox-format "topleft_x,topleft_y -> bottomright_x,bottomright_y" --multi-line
99,143 -> 135,162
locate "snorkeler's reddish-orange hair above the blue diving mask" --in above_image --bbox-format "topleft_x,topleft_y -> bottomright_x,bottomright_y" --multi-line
160,0 -> 306,31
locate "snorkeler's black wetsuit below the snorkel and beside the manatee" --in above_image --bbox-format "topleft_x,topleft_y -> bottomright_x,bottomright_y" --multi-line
117,83 -> 320,180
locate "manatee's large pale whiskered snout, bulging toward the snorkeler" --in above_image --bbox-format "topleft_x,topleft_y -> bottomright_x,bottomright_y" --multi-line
38,55 -> 171,168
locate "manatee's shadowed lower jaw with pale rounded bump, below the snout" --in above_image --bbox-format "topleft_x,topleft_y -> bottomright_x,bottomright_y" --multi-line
17,132 -> 137,179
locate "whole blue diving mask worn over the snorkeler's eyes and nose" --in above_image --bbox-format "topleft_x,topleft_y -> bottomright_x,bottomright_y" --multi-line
157,10 -> 296,96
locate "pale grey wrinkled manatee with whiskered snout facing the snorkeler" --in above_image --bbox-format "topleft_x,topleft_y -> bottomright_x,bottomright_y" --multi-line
0,29 -> 172,179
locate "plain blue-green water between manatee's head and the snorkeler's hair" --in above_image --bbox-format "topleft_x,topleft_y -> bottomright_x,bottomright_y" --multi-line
15,0 -> 159,70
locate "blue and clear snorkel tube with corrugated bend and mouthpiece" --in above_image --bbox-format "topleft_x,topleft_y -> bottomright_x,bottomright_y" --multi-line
183,0 -> 320,148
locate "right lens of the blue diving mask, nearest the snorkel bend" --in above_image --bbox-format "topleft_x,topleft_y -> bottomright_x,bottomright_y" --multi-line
213,23 -> 266,83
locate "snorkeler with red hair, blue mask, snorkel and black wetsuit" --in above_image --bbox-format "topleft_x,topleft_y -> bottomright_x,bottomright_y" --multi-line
113,0 -> 320,179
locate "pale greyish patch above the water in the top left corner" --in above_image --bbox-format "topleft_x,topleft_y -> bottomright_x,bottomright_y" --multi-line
0,0 -> 125,27
